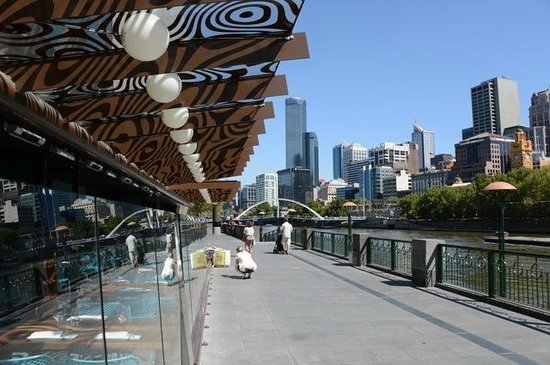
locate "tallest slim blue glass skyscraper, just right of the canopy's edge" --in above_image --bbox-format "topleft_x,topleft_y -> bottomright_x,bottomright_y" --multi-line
285,97 -> 307,168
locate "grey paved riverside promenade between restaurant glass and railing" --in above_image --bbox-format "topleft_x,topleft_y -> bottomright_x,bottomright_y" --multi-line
201,235 -> 550,365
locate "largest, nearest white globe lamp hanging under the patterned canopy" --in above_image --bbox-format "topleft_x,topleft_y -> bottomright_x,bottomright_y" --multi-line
121,12 -> 170,62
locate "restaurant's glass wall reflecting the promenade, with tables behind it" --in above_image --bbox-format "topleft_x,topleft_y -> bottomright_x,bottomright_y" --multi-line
0,175 -> 206,364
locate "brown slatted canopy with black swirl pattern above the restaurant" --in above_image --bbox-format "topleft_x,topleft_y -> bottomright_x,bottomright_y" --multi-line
0,0 -> 309,208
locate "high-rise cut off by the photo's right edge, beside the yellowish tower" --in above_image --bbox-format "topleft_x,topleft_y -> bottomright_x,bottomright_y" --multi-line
529,89 -> 550,156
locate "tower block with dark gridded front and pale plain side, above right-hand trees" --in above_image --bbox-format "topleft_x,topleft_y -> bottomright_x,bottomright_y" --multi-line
471,77 -> 520,135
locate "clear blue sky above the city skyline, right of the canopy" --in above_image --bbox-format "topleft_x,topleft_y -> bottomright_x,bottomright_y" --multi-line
237,0 -> 550,185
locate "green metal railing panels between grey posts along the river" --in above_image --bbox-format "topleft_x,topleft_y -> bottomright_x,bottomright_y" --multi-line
253,229 -> 550,311
